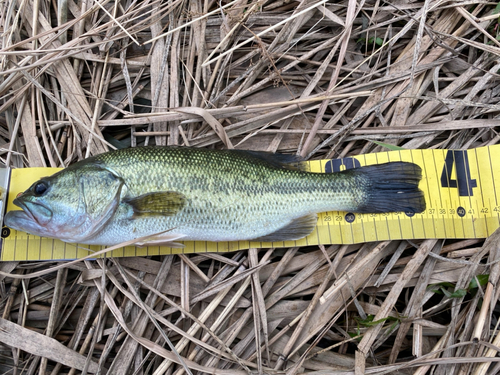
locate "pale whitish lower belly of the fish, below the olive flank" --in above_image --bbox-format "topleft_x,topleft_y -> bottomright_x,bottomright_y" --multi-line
86,189 -> 321,245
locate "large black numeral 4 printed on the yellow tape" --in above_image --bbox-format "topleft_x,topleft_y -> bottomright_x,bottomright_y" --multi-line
441,150 -> 477,197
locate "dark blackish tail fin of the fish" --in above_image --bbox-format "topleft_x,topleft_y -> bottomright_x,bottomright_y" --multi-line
349,162 -> 425,213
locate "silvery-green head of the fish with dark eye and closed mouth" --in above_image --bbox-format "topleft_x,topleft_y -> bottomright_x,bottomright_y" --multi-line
4,166 -> 124,242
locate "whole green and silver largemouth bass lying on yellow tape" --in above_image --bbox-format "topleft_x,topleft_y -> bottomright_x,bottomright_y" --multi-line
4,146 -> 425,246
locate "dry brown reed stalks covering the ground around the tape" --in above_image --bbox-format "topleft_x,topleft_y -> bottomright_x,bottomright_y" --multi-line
0,0 -> 500,375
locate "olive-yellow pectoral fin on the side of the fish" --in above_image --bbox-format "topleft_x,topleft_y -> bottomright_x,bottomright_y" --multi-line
124,191 -> 186,218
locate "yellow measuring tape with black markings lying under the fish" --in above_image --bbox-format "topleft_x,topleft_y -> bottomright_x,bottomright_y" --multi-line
0,145 -> 500,261
